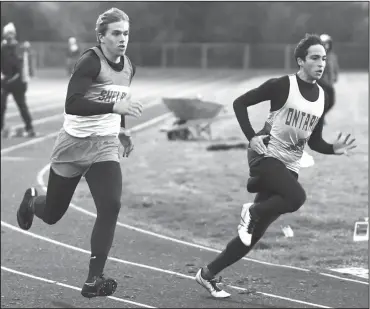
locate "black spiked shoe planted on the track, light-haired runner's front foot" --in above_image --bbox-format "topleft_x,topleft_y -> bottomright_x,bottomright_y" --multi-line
81,274 -> 117,298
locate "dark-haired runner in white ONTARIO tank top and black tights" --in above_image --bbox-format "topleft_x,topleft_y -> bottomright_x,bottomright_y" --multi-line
195,35 -> 356,298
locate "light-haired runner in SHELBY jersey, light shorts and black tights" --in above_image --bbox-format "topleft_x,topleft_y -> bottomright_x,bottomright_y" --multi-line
17,8 -> 142,298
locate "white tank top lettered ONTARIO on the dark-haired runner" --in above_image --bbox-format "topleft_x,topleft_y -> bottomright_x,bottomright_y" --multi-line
265,75 -> 325,173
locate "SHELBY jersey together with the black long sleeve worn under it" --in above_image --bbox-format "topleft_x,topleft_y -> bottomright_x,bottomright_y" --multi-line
64,47 -> 135,137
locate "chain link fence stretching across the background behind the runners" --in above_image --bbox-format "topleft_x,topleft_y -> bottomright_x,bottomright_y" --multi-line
32,42 -> 369,70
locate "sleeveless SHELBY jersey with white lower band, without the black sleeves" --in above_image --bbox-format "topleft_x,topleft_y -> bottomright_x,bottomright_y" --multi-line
63,47 -> 132,137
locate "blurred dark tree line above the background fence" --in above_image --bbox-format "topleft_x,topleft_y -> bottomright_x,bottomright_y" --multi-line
1,1 -> 369,45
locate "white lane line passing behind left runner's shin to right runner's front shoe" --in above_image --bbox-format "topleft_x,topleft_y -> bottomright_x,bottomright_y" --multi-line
1,221 -> 331,308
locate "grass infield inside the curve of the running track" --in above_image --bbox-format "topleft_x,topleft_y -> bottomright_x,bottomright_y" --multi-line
67,73 -> 369,269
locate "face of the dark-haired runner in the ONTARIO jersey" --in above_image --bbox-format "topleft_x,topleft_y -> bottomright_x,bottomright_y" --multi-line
298,44 -> 326,81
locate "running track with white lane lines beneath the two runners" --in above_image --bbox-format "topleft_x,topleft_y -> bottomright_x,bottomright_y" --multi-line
1,71 -> 369,308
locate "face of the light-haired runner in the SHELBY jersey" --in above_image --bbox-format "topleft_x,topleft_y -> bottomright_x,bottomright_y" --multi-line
99,20 -> 130,58
